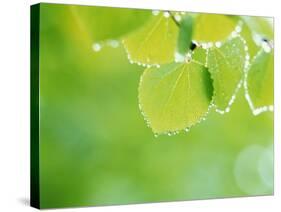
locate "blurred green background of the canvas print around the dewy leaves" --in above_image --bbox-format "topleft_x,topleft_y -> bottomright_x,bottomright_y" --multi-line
40,4 -> 273,208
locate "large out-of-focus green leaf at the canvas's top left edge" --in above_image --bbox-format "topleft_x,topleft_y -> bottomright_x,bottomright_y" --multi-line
68,5 -> 152,41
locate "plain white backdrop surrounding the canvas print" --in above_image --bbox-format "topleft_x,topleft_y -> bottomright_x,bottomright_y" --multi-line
0,0 -> 281,212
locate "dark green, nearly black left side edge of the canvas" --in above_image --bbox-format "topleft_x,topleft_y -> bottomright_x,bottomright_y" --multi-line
30,4 -> 40,208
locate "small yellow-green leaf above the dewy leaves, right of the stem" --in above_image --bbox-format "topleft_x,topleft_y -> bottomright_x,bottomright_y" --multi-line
193,14 -> 237,42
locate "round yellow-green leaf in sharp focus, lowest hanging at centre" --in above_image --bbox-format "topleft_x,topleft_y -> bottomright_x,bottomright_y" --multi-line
139,62 -> 213,134
